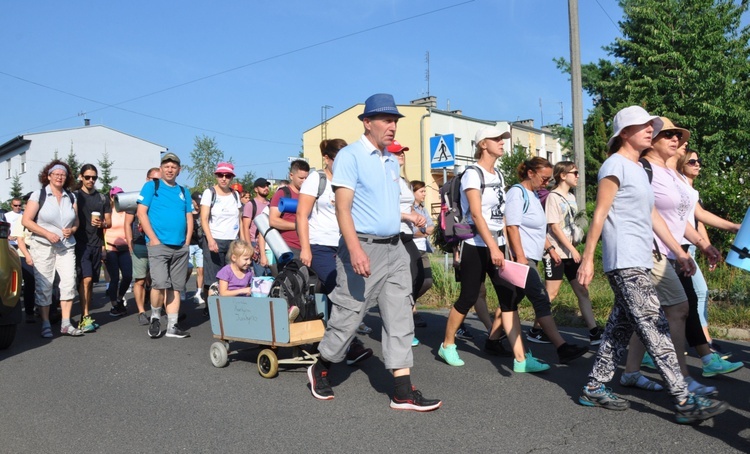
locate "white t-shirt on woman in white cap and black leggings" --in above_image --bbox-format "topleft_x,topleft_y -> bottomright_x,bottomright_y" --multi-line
461,165 -> 505,247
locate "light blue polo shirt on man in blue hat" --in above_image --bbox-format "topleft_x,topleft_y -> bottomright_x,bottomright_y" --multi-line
331,134 -> 401,236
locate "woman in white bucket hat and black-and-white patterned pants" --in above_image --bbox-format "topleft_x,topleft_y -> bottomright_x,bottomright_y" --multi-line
578,106 -> 728,424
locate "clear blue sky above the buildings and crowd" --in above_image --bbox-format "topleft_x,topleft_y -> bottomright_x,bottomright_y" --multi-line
0,0 -> 622,182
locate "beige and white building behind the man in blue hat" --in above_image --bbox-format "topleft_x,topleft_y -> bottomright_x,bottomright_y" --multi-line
302,96 -> 566,212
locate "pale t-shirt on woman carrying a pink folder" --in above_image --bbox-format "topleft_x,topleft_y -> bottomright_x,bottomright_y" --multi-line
505,185 -> 547,262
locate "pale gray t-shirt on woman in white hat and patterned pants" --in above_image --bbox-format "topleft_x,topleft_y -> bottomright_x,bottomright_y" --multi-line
598,153 -> 654,272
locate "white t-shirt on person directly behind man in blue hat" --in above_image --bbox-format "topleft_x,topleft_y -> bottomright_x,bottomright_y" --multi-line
299,172 -> 341,246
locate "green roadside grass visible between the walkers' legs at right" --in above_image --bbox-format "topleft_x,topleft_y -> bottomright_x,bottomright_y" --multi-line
419,245 -> 750,335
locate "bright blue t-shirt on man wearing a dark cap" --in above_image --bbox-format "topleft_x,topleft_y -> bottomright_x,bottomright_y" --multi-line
138,180 -> 193,246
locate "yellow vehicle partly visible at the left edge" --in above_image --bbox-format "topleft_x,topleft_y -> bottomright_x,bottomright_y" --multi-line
0,222 -> 22,350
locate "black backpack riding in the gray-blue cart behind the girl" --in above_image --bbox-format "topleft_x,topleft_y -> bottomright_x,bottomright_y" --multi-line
268,259 -> 323,321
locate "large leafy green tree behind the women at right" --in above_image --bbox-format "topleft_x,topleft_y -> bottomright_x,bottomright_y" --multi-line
558,0 -> 750,246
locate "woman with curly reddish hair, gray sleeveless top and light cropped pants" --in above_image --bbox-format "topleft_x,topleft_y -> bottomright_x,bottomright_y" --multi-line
22,159 -> 83,338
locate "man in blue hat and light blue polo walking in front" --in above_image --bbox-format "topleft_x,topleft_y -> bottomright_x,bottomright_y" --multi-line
307,93 -> 442,411
